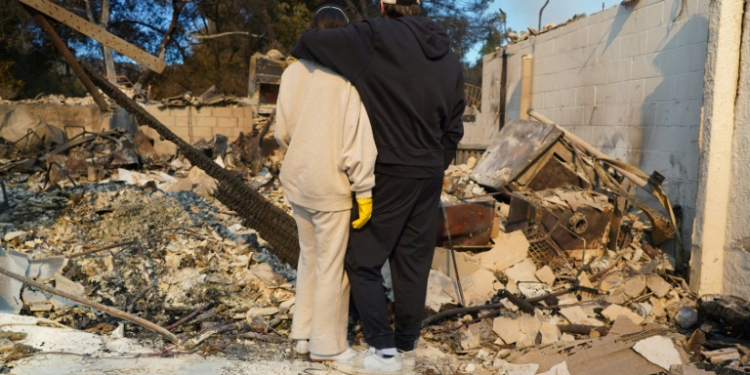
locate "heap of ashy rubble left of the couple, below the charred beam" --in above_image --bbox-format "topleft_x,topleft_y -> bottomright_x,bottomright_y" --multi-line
0,175 -> 295,362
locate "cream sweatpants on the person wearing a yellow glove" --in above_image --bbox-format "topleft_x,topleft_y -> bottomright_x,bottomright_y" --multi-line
290,203 -> 351,355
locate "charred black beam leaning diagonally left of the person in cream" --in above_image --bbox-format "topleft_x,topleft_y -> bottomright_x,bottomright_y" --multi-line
84,66 -> 299,268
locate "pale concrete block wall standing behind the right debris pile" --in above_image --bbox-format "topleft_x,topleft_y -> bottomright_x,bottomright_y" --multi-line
500,0 -> 709,244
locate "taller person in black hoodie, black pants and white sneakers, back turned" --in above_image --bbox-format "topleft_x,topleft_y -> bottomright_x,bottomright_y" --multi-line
292,0 -> 465,374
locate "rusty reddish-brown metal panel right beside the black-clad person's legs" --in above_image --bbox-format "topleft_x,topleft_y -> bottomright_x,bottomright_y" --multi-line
437,198 -> 495,247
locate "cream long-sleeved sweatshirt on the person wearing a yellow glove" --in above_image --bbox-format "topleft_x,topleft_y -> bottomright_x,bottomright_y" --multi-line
276,60 -> 378,212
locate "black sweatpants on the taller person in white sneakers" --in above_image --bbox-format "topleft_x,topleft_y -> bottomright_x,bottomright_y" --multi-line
346,172 -> 443,351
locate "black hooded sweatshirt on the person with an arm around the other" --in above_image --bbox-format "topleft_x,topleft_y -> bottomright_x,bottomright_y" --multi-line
292,16 -> 466,178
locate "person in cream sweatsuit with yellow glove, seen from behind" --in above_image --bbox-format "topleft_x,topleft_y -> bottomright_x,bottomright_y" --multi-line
275,2 -> 377,360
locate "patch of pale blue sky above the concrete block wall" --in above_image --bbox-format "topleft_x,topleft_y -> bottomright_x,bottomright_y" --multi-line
468,0 -> 622,61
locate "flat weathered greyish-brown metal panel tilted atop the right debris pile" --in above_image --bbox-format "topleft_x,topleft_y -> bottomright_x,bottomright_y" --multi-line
472,120 -> 563,190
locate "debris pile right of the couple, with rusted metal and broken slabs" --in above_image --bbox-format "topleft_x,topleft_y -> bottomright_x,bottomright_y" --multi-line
419,116 -> 750,375
